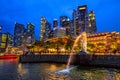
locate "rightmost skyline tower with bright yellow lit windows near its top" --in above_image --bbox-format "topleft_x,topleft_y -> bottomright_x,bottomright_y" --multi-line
88,11 -> 97,33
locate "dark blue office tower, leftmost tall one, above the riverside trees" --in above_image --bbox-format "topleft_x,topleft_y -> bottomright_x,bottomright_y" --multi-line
14,23 -> 25,46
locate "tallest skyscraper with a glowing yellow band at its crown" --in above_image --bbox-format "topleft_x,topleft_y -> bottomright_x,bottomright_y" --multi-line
77,5 -> 88,34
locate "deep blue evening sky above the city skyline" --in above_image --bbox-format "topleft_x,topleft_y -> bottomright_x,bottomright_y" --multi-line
0,0 -> 120,39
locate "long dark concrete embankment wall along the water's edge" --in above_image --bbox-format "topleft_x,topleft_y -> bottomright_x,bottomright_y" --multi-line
19,55 -> 120,68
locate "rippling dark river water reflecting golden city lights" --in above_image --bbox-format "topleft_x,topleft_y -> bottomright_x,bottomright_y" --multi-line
0,59 -> 120,80
